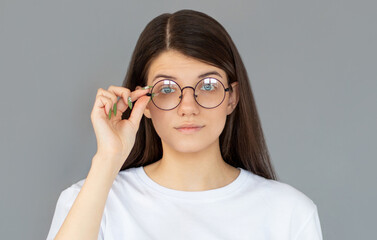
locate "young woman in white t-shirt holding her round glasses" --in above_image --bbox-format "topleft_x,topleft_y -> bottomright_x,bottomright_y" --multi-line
47,10 -> 322,240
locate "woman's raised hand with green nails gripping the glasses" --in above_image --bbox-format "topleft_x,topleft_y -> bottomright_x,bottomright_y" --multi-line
91,86 -> 150,169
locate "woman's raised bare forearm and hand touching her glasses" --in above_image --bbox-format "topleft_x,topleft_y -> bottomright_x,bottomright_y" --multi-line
51,86 -> 150,240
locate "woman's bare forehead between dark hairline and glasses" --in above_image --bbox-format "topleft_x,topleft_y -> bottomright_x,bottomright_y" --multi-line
147,50 -> 226,83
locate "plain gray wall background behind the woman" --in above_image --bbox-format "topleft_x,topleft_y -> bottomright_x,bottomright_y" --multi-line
0,0 -> 377,240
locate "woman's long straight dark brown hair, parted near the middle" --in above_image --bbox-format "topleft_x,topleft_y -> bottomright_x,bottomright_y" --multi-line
121,10 -> 277,180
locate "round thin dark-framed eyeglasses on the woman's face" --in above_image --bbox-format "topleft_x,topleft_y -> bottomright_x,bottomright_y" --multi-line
147,78 -> 230,111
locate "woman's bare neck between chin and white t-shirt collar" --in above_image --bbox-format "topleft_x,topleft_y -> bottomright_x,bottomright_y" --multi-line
144,141 -> 240,191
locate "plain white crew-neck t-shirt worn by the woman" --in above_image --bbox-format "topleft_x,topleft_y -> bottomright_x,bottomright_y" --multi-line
47,167 -> 322,240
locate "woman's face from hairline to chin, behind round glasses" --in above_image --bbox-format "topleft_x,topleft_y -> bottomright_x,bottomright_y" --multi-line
144,50 -> 238,152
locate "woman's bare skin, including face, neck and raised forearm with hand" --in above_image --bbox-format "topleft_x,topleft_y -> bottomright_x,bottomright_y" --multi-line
55,50 -> 240,240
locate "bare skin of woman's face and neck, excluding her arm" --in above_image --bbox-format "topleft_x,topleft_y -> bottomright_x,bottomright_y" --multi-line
137,50 -> 240,191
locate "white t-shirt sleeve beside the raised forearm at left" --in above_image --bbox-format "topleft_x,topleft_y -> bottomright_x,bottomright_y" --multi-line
47,185 -> 104,240
